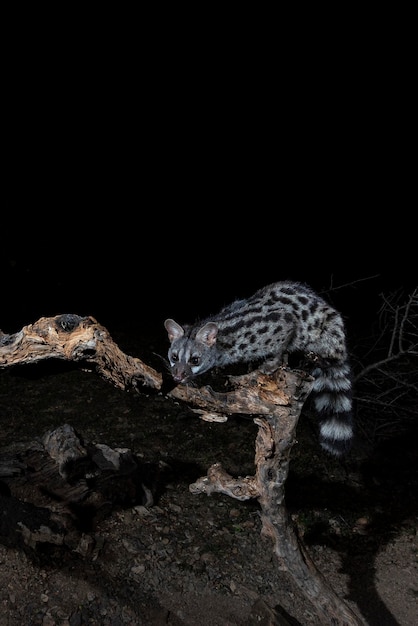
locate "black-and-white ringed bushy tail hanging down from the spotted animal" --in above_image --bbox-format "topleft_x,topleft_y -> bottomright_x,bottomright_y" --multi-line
312,361 -> 354,456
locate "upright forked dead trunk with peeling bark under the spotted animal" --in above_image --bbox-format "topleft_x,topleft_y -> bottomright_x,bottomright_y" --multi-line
170,369 -> 363,626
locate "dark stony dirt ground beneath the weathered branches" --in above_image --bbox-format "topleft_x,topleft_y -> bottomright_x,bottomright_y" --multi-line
0,329 -> 418,626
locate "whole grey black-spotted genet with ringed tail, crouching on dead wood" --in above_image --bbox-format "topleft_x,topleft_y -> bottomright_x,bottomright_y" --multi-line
164,281 -> 353,456
